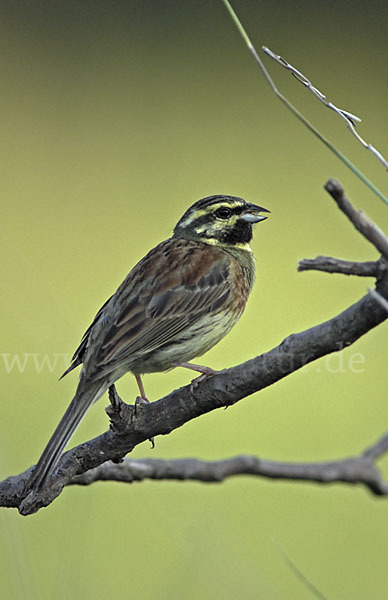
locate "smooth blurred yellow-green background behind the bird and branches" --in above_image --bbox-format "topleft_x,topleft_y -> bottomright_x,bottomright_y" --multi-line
0,0 -> 388,600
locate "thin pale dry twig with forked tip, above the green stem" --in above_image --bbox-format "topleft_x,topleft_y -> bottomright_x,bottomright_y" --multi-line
263,46 -> 388,171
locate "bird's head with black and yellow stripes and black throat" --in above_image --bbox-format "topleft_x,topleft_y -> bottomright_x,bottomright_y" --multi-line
174,196 -> 270,249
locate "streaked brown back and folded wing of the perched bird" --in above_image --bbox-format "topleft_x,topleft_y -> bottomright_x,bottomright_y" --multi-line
97,238 -> 233,372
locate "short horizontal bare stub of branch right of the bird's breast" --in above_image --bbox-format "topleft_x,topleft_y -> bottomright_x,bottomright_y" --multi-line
298,256 -> 380,278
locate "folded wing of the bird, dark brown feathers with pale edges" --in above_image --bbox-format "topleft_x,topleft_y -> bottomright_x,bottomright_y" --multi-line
97,239 -> 230,371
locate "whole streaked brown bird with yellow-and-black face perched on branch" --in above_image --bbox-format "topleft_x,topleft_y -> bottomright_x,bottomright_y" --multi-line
29,196 -> 270,490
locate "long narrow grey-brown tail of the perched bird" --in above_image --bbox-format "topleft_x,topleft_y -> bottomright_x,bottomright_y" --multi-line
28,379 -> 106,491
